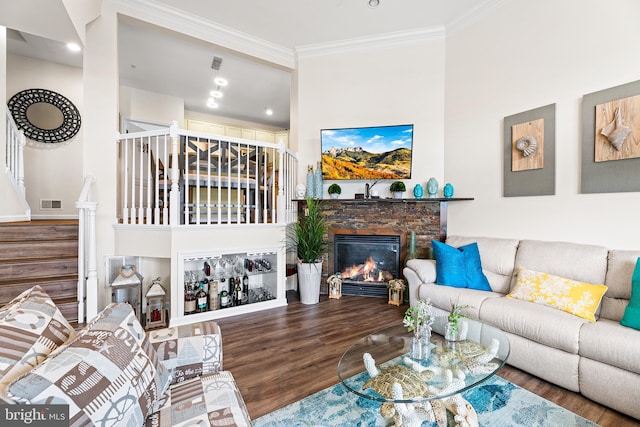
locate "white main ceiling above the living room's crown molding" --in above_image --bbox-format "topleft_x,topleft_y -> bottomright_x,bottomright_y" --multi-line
156,0 -> 496,49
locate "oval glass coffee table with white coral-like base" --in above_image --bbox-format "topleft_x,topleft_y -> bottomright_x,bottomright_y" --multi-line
338,316 -> 509,426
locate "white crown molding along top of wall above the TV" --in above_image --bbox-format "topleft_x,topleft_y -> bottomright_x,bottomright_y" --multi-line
296,25 -> 445,58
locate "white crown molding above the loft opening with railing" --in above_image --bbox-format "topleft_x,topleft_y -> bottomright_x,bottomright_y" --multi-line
108,0 -> 296,69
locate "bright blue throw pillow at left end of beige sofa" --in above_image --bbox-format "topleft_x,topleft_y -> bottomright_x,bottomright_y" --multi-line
431,240 -> 491,291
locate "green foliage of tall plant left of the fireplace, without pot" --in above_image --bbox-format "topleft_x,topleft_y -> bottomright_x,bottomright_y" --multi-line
294,198 -> 329,263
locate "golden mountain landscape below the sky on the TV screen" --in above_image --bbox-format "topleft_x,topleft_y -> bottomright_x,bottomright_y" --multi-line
322,147 -> 411,179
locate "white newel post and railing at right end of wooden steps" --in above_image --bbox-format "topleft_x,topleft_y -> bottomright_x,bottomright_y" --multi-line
76,174 -> 98,323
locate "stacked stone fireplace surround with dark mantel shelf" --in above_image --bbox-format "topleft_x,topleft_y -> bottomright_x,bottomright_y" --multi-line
298,198 -> 473,294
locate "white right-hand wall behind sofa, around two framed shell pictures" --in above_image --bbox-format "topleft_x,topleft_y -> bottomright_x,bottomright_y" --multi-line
445,0 -> 640,249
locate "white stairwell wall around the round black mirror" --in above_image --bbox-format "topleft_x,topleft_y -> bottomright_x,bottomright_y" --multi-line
6,54 -> 84,218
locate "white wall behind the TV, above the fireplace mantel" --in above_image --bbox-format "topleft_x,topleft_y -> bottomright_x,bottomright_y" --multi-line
298,37 -> 445,198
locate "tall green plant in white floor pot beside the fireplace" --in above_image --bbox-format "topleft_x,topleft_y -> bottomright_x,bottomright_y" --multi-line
292,198 -> 328,304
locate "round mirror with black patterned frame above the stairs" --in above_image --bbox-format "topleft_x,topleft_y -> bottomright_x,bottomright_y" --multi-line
8,89 -> 81,144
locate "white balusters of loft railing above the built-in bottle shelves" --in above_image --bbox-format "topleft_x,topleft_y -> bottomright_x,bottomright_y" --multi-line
118,123 -> 297,226
